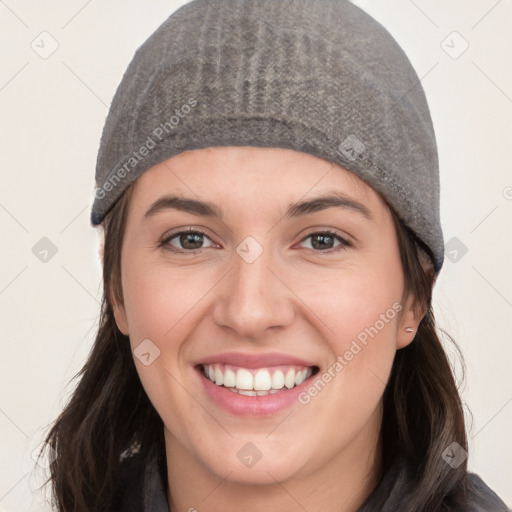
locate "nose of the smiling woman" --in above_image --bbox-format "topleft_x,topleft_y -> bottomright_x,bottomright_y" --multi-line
213,243 -> 295,341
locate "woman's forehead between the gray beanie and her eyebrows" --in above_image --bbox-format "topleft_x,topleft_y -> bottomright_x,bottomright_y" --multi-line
130,147 -> 387,221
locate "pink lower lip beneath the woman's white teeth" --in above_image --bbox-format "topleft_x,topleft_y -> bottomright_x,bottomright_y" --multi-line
197,368 -> 311,416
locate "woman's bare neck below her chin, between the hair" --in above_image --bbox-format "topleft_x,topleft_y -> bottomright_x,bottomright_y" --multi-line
165,408 -> 382,512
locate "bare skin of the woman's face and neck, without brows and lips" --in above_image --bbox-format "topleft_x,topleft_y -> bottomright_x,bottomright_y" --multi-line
114,147 -> 424,512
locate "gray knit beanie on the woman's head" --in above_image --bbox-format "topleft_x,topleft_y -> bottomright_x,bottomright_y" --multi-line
91,0 -> 444,272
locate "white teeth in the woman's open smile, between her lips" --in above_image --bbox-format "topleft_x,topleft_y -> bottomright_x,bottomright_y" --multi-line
199,363 -> 319,396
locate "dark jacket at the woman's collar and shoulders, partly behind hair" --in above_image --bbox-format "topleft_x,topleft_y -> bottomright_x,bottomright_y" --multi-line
113,454 -> 511,512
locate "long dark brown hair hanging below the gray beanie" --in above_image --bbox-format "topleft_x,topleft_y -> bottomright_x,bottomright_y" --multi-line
40,185 -> 467,512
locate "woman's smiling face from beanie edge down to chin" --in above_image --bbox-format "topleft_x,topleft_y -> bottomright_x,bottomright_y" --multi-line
115,147 -> 419,483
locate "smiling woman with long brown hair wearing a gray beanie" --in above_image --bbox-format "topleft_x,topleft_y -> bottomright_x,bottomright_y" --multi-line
41,0 -> 507,512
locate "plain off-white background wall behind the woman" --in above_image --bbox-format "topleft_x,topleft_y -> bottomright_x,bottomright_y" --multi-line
0,0 -> 512,512
